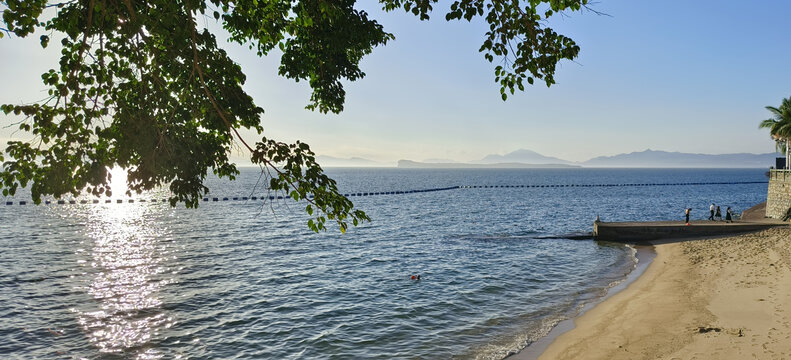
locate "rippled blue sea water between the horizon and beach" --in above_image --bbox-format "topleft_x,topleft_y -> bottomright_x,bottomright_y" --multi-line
0,169 -> 767,359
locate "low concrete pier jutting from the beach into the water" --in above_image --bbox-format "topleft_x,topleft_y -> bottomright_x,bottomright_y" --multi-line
593,219 -> 789,242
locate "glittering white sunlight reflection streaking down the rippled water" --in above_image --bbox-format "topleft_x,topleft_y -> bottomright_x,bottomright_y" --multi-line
78,201 -> 174,359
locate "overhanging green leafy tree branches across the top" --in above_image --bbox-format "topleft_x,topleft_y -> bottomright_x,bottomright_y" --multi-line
0,0 -> 588,231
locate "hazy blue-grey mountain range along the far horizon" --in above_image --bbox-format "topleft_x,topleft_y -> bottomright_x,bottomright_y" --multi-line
317,149 -> 780,168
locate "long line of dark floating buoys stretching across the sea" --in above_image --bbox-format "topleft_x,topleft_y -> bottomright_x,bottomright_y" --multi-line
0,181 -> 769,205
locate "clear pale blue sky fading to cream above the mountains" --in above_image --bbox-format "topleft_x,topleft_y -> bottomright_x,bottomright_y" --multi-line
0,0 -> 791,164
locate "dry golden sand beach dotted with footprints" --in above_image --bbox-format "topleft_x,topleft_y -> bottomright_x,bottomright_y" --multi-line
539,227 -> 791,360
